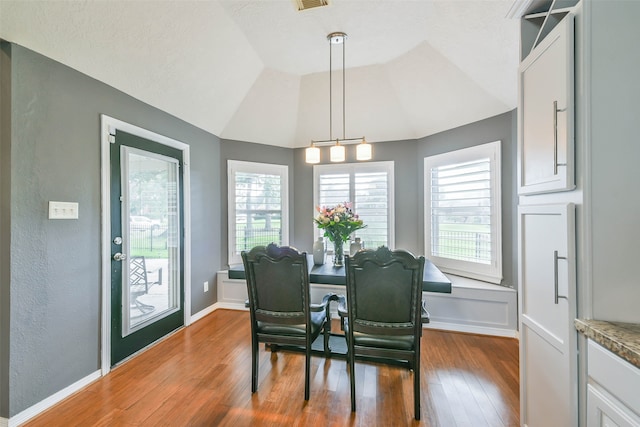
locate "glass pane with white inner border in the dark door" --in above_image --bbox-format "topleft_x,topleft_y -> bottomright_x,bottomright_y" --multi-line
122,147 -> 180,336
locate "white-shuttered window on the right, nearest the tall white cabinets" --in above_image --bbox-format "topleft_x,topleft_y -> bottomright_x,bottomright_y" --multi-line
424,141 -> 502,283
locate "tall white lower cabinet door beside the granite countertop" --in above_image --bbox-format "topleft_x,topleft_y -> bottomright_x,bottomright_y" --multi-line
518,203 -> 578,427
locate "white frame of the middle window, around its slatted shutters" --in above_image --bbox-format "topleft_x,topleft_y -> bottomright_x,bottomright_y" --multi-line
310,160 -> 395,248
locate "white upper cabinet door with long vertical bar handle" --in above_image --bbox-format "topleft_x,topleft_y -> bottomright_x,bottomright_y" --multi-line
518,14 -> 574,194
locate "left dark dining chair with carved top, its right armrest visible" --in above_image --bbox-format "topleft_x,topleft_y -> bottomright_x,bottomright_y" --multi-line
241,243 -> 331,400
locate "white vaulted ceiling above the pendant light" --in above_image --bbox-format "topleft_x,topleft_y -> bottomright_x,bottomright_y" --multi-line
0,0 -> 519,147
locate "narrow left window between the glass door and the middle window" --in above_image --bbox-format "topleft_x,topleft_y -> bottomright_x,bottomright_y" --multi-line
227,160 -> 289,264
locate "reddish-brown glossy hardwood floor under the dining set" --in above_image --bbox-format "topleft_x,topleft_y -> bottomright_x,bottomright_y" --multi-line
25,310 -> 519,427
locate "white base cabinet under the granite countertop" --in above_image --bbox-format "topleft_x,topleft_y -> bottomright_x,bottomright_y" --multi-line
587,340 -> 640,427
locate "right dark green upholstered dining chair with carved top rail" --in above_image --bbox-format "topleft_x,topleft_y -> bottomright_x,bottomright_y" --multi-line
344,246 -> 428,420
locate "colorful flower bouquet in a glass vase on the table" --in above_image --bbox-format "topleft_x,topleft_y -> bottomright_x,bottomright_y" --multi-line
314,202 -> 366,267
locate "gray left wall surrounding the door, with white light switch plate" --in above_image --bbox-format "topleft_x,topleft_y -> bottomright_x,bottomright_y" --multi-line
0,43 -> 221,417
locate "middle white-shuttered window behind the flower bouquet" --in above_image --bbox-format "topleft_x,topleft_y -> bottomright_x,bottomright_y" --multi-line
313,162 -> 394,248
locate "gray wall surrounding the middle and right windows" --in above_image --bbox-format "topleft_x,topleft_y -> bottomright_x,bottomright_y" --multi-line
291,110 -> 517,287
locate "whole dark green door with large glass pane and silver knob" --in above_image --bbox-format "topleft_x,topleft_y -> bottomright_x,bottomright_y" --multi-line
110,130 -> 184,366
